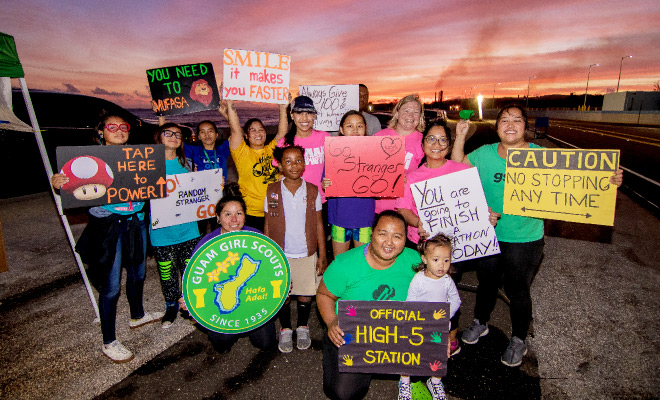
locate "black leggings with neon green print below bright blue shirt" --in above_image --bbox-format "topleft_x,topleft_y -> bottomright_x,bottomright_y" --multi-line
154,237 -> 201,306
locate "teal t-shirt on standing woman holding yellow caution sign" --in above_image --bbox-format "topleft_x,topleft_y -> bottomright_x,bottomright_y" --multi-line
468,143 -> 543,243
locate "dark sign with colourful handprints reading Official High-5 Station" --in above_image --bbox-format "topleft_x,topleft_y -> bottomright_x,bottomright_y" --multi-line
337,300 -> 449,376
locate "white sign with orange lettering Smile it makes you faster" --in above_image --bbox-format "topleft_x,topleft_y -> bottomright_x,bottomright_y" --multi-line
222,49 -> 291,104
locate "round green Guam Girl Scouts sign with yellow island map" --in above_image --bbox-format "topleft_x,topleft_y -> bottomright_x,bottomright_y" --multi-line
182,231 -> 291,333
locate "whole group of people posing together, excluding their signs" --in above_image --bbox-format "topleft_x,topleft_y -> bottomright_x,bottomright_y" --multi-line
51,85 -> 622,399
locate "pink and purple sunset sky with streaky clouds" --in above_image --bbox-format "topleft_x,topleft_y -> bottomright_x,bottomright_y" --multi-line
0,0 -> 660,108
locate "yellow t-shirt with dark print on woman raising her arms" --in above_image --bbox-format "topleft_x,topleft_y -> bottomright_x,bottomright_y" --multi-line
231,140 -> 279,217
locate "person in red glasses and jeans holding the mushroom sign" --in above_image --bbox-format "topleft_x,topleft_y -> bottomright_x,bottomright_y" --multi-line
51,114 -> 163,363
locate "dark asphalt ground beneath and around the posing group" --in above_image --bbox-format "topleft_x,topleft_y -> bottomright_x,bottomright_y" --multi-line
0,122 -> 660,399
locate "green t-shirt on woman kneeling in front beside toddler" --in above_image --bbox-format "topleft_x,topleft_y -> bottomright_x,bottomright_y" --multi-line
323,245 -> 422,314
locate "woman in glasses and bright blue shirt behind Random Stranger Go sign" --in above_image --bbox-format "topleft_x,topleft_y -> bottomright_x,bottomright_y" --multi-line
149,122 -> 201,329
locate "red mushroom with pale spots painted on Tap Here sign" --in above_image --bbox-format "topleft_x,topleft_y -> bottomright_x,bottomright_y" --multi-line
60,156 -> 115,200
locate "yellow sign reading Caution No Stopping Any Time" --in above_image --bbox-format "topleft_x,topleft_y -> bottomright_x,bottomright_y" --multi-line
503,149 -> 619,226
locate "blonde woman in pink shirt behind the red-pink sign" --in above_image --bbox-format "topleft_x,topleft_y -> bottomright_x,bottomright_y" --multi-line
374,94 -> 425,214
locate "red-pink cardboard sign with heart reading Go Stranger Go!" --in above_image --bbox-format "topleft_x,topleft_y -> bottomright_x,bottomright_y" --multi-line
325,136 -> 405,197
